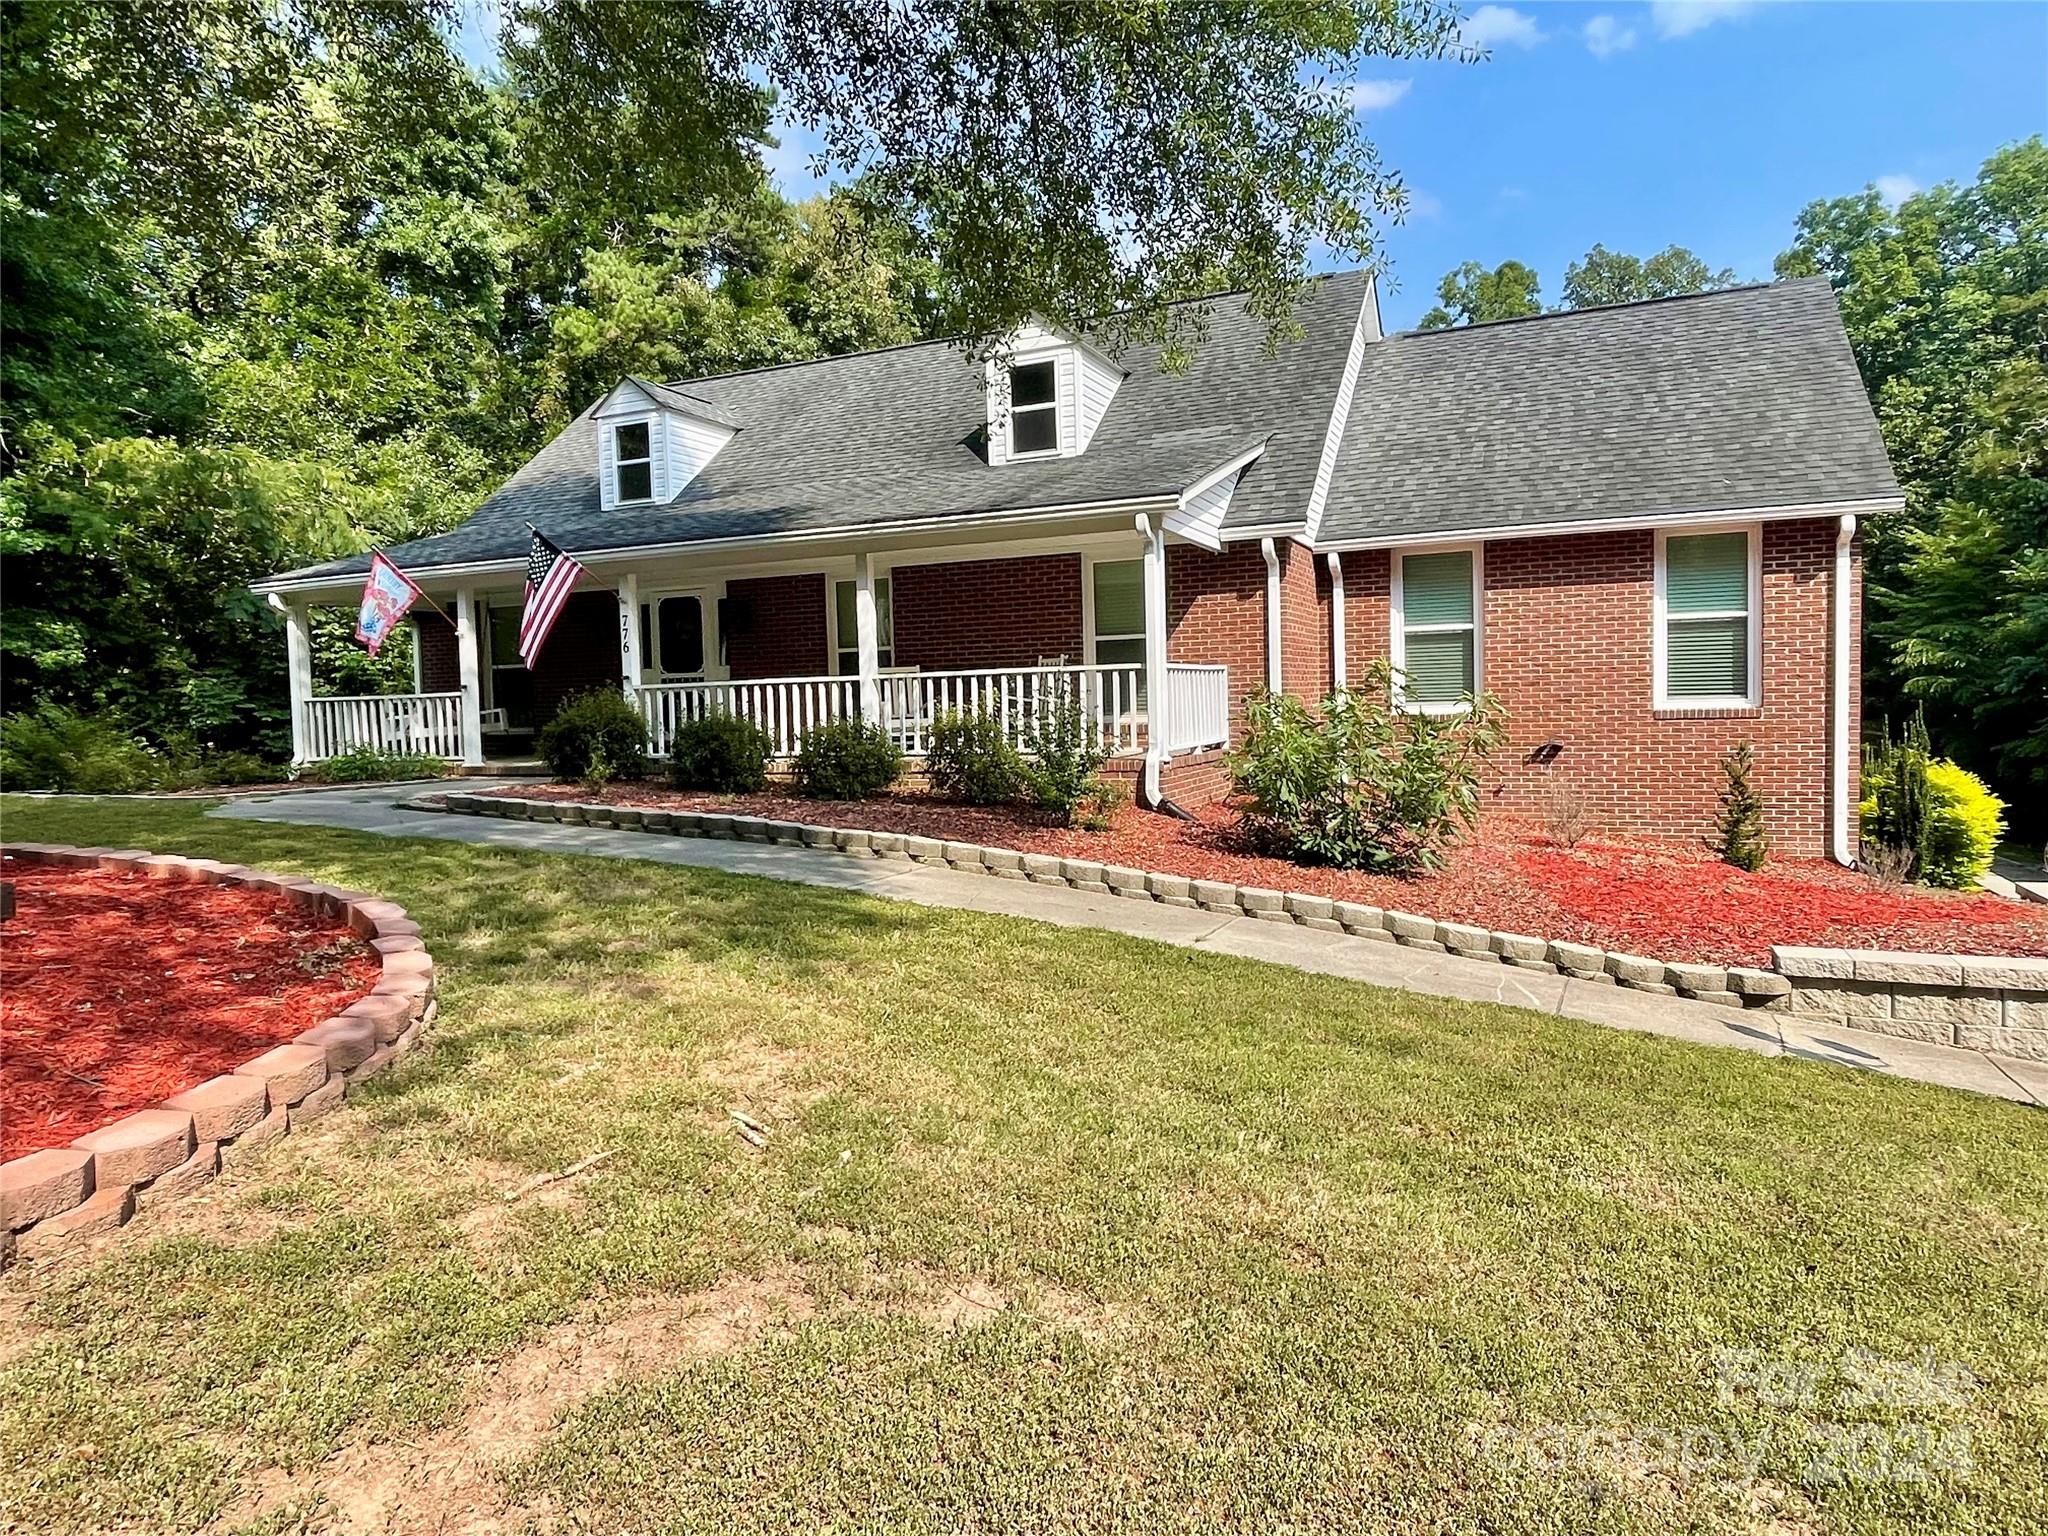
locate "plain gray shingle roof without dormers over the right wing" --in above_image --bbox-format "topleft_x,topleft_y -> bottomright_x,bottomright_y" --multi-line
1317,279 -> 1898,543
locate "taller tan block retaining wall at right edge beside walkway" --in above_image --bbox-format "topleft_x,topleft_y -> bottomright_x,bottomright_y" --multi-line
1772,944 -> 2048,1061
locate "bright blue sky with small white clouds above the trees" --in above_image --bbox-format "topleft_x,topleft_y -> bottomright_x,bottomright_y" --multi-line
465,0 -> 2048,330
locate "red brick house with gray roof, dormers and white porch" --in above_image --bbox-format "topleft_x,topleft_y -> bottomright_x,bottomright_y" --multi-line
258,274 -> 1903,858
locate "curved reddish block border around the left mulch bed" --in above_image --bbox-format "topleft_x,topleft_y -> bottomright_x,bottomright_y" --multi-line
0,844 -> 434,1268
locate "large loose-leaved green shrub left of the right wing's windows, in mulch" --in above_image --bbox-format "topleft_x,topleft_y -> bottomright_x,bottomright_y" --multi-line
1231,659 -> 1505,874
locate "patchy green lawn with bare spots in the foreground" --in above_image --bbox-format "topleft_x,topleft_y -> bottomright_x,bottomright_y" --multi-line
0,799 -> 2048,1534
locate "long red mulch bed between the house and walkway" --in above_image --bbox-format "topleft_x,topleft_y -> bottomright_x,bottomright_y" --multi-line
475,784 -> 2048,965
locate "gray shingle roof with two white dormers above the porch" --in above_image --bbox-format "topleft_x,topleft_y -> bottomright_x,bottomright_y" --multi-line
264,272 -> 1366,580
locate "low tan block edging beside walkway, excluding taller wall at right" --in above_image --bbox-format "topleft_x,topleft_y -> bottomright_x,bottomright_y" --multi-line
419,793 -> 1843,1010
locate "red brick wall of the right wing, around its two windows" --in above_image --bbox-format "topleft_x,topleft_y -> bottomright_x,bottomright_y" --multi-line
1343,520 -> 1862,856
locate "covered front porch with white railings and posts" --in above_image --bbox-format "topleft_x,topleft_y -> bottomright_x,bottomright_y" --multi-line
281,518 -> 1233,794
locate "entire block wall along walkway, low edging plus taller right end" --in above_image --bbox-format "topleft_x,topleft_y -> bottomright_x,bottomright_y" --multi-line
423,793 -> 2048,1061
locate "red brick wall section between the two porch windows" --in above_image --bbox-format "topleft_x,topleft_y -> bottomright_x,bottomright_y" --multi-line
889,555 -> 1087,672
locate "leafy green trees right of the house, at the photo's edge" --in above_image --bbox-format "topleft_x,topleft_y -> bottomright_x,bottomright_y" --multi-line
1778,137 -> 2048,805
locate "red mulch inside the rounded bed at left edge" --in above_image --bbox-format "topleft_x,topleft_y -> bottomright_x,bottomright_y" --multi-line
0,860 -> 379,1159
